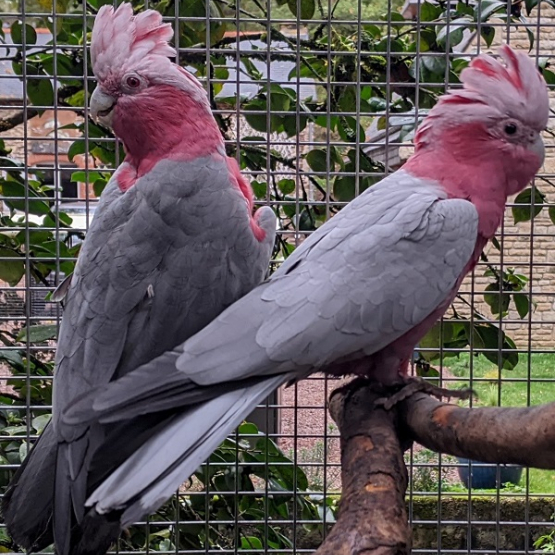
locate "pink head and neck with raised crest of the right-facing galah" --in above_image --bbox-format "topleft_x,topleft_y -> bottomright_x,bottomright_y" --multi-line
404,45 -> 549,237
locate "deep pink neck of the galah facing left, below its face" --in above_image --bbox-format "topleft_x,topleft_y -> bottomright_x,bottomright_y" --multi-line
112,85 -> 223,190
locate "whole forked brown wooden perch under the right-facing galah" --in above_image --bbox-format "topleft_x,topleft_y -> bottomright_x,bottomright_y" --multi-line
315,378 -> 555,555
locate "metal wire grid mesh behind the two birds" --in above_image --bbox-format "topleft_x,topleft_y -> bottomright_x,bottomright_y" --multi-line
0,0 -> 555,554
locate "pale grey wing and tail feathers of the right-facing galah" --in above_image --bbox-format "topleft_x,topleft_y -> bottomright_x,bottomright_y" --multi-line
57,171 -> 478,523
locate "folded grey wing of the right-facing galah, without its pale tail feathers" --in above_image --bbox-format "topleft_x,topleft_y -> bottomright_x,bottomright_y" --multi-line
64,172 -> 478,427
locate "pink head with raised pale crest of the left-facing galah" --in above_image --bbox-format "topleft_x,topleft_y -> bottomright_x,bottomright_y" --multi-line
90,3 -> 221,165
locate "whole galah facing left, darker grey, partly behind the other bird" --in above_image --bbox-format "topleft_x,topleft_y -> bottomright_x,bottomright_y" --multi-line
3,4 -> 276,555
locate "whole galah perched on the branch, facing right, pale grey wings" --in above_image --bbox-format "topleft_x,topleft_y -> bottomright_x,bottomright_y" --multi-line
55,46 -> 549,552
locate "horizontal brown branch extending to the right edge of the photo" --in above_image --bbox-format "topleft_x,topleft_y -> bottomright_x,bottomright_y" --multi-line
399,393 -> 555,469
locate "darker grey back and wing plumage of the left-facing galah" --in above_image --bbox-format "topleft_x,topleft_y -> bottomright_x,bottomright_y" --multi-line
3,156 -> 275,553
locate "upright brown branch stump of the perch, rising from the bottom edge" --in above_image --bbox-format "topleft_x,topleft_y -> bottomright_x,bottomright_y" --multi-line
315,380 -> 411,555
